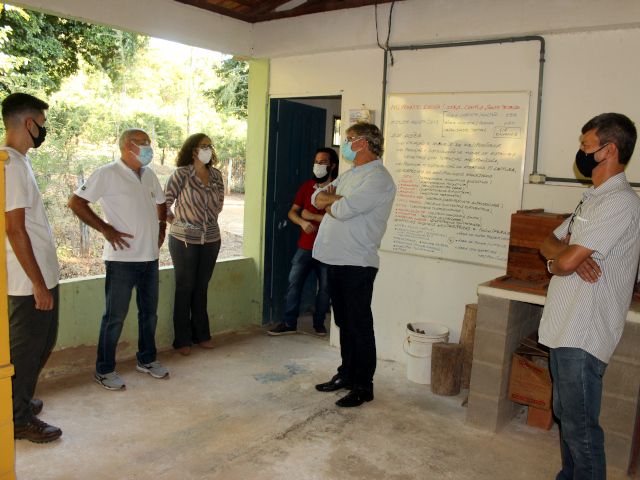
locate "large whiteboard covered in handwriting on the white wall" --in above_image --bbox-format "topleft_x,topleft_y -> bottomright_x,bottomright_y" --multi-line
381,92 -> 530,267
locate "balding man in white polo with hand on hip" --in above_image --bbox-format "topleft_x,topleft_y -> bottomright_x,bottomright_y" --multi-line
69,129 -> 169,390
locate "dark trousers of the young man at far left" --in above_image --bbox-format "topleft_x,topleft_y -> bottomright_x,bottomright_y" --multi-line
9,286 -> 59,427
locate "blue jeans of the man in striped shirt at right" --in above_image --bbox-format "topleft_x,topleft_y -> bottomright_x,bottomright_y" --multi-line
549,348 -> 607,480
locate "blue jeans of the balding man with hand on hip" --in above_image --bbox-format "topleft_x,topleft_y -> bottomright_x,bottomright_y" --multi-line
96,260 -> 159,374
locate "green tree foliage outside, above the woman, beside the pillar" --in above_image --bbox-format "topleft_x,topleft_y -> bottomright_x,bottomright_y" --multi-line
203,58 -> 249,119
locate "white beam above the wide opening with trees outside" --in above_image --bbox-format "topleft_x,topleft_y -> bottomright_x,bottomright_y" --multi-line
11,0 -> 252,55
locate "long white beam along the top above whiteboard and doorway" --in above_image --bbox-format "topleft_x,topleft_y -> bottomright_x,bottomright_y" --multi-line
253,0 -> 640,58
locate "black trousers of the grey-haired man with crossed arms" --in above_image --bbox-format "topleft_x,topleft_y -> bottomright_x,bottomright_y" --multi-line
329,265 -> 378,392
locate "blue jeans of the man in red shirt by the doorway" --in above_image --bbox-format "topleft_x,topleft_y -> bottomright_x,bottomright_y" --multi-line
282,248 -> 329,328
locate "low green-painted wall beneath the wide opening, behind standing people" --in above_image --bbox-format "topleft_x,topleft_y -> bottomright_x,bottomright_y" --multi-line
43,258 -> 262,377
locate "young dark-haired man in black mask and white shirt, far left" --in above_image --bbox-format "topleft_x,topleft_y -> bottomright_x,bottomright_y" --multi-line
0,93 -> 62,443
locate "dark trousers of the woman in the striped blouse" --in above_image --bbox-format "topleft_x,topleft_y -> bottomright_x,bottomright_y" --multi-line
169,235 -> 221,348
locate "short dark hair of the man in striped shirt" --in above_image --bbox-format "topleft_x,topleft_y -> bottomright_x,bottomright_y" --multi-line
582,113 -> 638,165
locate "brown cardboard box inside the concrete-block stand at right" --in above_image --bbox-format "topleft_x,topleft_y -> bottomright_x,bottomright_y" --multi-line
509,353 -> 552,410
